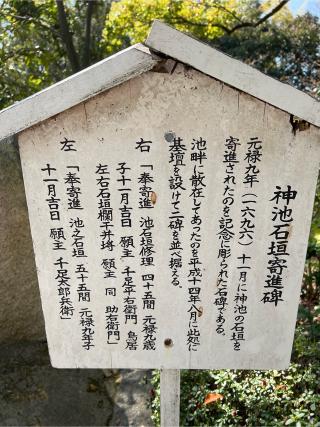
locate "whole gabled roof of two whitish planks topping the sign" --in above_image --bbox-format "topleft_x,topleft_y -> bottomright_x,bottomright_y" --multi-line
0,21 -> 320,141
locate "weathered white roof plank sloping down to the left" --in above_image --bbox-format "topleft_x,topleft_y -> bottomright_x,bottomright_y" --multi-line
0,44 -> 159,141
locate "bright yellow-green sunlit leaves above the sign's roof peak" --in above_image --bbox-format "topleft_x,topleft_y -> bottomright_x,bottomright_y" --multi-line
103,0 -> 258,53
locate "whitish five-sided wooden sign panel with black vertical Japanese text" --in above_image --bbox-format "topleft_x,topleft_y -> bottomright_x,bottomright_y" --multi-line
19,66 -> 319,369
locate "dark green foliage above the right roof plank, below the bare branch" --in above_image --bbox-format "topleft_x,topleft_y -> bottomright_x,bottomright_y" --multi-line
214,14 -> 320,95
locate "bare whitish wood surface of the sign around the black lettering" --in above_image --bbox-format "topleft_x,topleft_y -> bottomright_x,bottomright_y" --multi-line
19,64 -> 320,369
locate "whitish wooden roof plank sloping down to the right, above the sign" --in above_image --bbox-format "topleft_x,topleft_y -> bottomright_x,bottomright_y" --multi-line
146,21 -> 320,126
